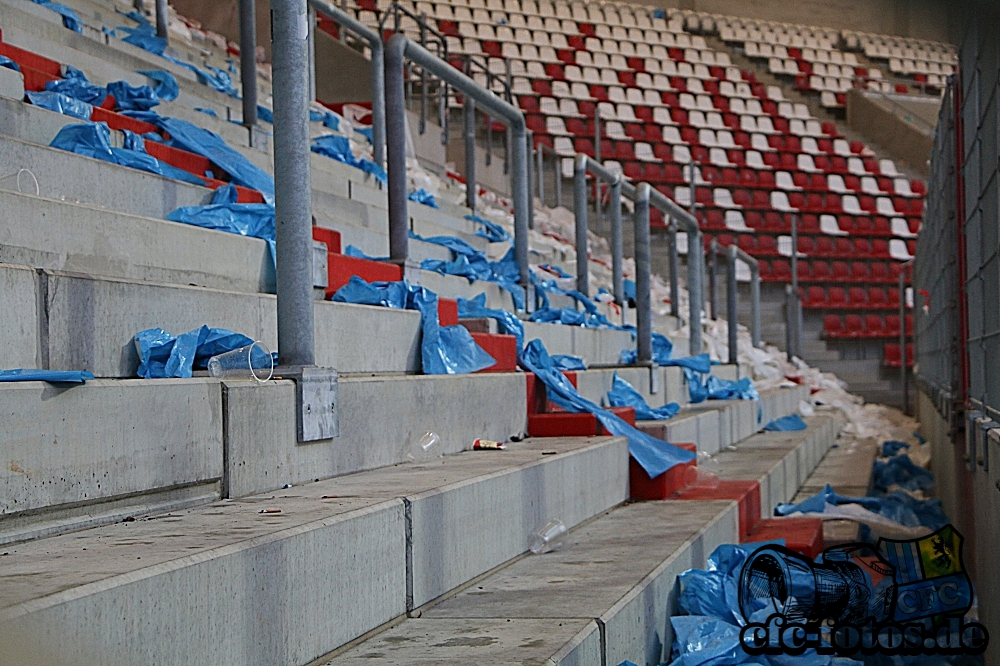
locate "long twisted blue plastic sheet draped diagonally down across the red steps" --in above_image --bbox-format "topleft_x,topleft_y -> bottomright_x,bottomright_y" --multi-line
521,340 -> 695,478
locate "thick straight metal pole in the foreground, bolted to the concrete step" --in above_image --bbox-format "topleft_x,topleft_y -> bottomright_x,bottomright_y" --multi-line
271,0 -> 316,365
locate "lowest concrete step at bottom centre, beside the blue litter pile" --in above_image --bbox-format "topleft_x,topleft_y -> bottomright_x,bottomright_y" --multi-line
326,501 -> 737,666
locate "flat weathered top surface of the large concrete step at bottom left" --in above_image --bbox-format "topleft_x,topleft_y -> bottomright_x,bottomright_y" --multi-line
0,437 -> 624,608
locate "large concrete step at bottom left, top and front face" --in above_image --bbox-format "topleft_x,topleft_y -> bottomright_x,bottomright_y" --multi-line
0,438 -> 624,664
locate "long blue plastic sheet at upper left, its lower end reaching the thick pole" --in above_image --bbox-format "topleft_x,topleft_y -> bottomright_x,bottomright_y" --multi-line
125,111 -> 274,204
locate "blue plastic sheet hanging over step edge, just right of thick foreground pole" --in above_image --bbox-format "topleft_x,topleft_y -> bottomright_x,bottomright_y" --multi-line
333,275 -> 496,375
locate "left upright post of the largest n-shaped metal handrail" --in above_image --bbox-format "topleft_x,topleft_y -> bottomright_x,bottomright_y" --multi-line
385,34 -> 410,265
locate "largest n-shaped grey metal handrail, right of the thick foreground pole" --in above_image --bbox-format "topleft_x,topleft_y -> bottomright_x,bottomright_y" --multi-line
385,33 -> 531,290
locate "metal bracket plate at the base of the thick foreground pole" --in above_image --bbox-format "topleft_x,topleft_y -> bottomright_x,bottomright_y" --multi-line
275,366 -> 340,443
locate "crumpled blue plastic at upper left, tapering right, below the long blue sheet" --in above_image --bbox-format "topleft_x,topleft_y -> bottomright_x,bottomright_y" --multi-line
49,122 -> 204,185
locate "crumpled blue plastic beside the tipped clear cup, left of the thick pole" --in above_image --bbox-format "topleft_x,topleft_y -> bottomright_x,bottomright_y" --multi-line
135,326 -> 254,379
